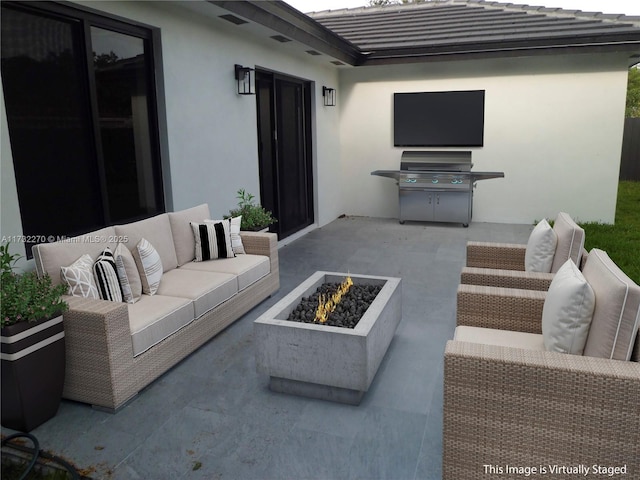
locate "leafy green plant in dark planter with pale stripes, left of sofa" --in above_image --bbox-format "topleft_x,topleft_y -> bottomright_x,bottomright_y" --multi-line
0,244 -> 68,432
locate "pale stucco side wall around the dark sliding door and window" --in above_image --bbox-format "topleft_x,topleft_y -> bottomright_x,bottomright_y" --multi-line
0,1 -> 343,255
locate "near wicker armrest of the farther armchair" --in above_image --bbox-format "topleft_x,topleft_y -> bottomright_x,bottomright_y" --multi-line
460,267 -> 553,292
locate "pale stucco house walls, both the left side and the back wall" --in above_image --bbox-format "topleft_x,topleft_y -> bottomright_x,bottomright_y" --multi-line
0,1 -> 627,258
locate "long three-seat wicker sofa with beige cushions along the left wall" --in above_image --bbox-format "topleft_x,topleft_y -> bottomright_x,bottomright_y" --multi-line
33,204 -> 280,411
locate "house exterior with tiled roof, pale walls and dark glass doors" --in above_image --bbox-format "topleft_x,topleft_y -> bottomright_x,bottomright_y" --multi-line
0,0 -> 640,262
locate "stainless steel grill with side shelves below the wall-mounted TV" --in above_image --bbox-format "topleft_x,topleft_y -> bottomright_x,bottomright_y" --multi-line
371,150 -> 504,227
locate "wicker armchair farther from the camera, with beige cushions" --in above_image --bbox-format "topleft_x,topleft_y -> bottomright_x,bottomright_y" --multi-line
460,212 -> 586,291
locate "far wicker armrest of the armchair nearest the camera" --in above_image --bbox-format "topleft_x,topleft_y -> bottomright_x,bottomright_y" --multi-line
456,285 -> 546,333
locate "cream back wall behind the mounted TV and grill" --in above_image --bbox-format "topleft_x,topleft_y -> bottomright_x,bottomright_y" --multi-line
340,55 -> 627,223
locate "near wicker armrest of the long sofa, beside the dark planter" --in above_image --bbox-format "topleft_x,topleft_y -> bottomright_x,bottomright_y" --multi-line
63,297 -> 137,408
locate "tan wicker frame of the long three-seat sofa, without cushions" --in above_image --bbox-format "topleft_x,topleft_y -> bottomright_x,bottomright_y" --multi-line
63,232 -> 280,411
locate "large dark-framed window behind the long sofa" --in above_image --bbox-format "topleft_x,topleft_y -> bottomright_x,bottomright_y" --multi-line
1,2 -> 164,255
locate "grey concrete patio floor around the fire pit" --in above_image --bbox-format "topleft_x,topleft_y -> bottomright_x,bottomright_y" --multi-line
2,217 -> 532,480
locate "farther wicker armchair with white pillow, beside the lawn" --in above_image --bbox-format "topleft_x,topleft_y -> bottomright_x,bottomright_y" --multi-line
460,212 -> 586,291
